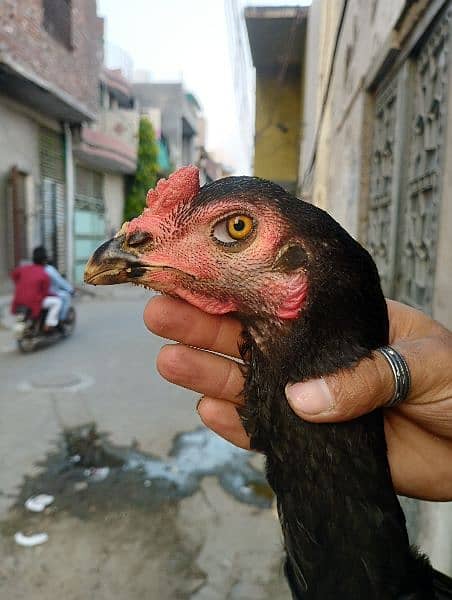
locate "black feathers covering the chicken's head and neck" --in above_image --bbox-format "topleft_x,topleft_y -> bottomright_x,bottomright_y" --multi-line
194,177 -> 452,600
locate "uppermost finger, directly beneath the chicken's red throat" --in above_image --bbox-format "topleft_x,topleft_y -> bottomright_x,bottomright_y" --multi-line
144,296 -> 242,357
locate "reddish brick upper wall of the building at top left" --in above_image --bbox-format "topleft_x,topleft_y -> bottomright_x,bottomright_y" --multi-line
0,0 -> 103,112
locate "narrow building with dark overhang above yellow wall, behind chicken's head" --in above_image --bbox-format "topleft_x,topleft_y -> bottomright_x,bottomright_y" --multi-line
245,7 -> 308,192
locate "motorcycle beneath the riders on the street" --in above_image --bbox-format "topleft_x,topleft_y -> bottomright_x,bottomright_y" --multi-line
13,306 -> 76,352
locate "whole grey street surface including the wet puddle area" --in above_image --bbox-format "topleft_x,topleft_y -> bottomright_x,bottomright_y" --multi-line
0,287 -> 289,600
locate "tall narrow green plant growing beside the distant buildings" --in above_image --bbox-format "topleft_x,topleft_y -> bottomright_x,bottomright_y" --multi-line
124,117 -> 158,221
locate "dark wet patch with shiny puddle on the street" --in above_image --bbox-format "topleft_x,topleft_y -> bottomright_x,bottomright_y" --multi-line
5,424 -> 273,520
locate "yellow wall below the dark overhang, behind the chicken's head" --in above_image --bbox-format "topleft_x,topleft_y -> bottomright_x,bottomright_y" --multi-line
254,69 -> 301,191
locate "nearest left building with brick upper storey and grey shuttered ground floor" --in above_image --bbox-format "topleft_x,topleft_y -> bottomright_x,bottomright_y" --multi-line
0,0 -> 102,288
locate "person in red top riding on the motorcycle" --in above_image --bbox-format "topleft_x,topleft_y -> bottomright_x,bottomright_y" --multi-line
11,246 -> 62,332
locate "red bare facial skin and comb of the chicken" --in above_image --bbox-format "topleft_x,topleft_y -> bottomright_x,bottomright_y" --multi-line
120,167 -> 308,321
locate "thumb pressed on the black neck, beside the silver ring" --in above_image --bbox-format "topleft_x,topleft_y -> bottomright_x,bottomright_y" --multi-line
286,352 -> 394,423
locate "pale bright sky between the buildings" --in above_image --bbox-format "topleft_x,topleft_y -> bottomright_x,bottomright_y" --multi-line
97,0 -> 310,174
